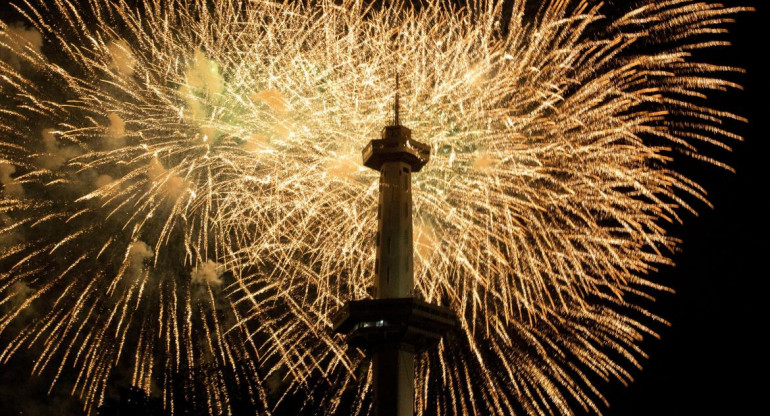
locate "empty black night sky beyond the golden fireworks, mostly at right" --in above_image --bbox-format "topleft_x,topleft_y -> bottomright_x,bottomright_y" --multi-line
0,0 -> 770,416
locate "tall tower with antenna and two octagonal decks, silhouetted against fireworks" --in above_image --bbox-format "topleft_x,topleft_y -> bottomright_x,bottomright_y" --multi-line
332,75 -> 456,416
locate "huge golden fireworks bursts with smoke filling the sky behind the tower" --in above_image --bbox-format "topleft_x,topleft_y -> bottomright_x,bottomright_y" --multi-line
0,0 -> 744,414
